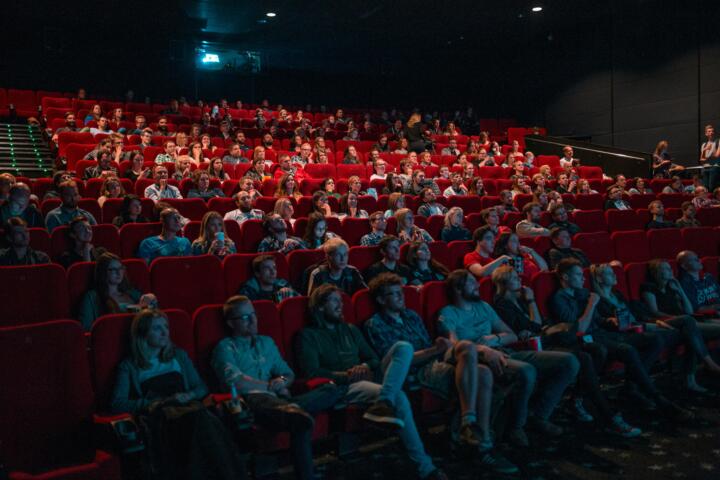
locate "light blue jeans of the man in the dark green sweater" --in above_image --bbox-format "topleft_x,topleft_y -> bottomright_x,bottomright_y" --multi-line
345,341 -> 435,477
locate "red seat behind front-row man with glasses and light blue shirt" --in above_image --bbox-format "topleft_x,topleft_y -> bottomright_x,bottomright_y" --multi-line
192,300 -> 285,392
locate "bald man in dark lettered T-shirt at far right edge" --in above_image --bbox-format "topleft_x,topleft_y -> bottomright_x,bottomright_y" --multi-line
676,250 -> 720,318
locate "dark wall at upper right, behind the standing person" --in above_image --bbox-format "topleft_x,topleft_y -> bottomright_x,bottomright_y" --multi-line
544,1 -> 720,165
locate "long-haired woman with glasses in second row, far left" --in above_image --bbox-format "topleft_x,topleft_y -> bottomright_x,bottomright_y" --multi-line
78,252 -> 158,331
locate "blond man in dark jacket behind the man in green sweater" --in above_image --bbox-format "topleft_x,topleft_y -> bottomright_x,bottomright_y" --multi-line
307,237 -> 367,297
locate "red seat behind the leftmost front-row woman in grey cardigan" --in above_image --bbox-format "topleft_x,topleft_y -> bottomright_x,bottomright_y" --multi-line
90,309 -> 195,413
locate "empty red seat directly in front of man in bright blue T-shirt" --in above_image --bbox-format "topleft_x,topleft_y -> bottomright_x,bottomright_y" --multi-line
150,255 -> 225,314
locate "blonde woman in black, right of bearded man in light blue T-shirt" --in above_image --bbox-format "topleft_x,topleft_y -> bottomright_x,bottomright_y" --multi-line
492,265 -> 642,438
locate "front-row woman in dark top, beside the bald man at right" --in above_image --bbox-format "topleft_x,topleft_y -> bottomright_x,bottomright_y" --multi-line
640,259 -> 720,392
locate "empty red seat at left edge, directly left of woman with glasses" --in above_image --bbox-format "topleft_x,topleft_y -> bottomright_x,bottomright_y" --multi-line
0,263 -> 70,326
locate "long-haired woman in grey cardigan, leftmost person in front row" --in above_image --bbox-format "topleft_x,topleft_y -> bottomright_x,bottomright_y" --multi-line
111,310 -> 245,480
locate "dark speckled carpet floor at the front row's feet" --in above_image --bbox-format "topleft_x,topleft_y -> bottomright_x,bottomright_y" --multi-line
280,374 -> 720,480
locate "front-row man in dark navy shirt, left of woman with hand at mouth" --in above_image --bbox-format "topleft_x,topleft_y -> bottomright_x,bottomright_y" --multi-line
549,258 -> 692,420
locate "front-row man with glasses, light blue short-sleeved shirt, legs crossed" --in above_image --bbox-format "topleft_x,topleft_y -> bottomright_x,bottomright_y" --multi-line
211,295 -> 339,480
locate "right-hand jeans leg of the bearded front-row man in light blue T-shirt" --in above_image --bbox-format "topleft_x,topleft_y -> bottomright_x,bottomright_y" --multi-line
510,351 -> 580,420
